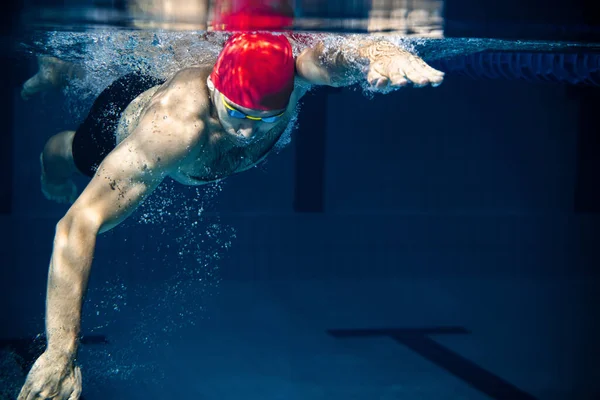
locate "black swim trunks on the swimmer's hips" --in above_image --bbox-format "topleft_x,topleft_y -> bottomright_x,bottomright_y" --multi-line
72,72 -> 164,177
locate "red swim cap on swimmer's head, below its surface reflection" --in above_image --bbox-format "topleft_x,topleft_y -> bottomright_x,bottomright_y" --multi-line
210,33 -> 295,111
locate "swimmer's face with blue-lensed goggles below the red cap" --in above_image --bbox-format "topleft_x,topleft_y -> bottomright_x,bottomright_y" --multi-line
208,78 -> 286,145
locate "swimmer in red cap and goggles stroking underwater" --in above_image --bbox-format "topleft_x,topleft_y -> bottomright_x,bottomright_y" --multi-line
18,32 -> 444,400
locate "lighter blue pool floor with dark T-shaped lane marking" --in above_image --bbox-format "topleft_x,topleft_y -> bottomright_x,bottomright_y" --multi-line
59,278 -> 600,400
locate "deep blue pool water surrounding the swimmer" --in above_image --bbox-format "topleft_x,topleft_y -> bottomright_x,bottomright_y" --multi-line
0,2 -> 600,400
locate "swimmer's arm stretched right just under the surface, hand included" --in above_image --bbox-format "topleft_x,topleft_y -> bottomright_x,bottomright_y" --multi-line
296,38 -> 444,90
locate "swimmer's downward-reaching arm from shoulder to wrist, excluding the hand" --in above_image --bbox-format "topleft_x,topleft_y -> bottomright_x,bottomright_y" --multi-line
46,81 -> 202,360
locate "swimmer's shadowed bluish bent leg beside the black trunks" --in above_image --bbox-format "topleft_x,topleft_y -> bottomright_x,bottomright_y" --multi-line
40,131 -> 77,203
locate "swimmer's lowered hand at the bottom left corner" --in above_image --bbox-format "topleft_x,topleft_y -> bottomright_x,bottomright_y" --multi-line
17,350 -> 81,400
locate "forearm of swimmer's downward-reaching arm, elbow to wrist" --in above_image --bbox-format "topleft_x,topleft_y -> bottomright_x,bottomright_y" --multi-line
46,214 -> 97,359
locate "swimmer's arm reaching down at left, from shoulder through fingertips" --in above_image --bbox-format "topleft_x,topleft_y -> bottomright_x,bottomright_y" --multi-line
19,72 -> 203,400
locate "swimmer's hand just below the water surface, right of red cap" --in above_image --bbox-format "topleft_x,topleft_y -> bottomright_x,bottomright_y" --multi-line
359,40 -> 444,91
